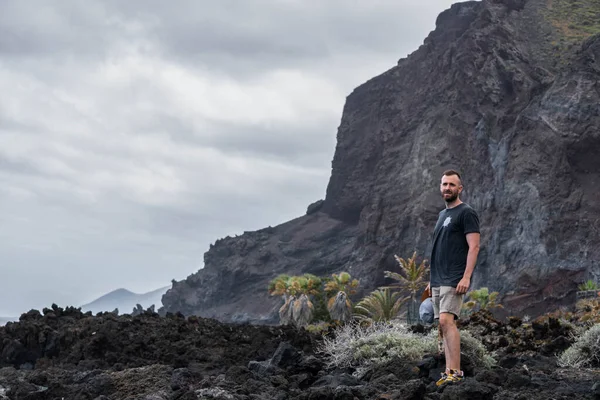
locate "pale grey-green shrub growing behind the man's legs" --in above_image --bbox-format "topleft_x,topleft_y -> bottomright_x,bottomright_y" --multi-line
319,321 -> 495,368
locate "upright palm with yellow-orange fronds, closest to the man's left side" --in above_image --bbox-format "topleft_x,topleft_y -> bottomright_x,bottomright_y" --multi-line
383,251 -> 427,322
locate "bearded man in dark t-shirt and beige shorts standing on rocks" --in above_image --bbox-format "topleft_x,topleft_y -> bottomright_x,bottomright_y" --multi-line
427,170 -> 480,386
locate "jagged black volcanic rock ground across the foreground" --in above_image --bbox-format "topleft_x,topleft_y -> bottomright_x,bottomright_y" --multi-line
0,307 -> 600,400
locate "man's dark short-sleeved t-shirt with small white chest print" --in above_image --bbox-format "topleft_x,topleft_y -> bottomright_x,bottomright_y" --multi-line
431,203 -> 479,287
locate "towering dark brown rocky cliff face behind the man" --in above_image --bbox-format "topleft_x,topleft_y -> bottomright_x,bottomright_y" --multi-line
163,0 -> 600,322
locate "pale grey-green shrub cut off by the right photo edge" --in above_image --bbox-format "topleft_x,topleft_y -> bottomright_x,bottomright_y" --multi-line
558,324 -> 600,368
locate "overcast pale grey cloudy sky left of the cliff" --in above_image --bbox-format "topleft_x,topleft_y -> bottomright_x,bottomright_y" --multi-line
0,0 -> 452,316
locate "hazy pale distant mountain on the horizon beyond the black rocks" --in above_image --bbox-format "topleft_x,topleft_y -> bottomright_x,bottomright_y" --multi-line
81,286 -> 169,314
